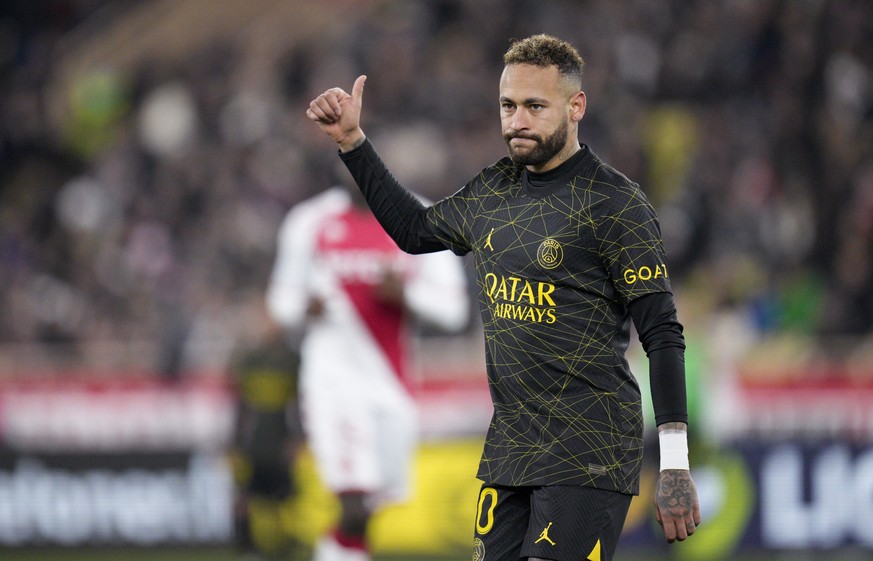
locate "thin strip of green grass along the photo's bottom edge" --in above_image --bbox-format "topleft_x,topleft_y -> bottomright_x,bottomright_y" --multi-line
0,547 -> 873,561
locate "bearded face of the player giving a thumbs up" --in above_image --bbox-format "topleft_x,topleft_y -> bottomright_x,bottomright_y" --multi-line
500,64 -> 585,172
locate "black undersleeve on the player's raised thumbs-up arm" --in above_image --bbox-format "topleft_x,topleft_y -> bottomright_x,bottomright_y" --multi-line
340,139 -> 447,253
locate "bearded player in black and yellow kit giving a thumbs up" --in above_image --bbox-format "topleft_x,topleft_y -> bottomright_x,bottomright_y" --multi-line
306,35 -> 700,561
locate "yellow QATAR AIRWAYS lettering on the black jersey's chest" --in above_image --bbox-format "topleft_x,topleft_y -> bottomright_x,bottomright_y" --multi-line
485,273 -> 557,323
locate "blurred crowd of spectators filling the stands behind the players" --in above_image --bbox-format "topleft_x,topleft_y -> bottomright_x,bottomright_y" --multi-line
0,0 -> 873,374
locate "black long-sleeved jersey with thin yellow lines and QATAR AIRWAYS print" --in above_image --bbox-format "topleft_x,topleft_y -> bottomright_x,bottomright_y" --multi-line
341,141 -> 687,494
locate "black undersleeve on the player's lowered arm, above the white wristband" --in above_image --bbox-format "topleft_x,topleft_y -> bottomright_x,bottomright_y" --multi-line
629,292 -> 688,425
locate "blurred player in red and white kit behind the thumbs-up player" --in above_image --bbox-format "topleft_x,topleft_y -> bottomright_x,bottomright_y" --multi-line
268,170 -> 469,561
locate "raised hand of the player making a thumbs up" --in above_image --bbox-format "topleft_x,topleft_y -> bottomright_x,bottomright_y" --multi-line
306,75 -> 367,152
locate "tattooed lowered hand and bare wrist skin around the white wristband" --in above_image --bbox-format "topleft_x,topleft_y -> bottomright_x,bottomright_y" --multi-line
655,423 -> 700,543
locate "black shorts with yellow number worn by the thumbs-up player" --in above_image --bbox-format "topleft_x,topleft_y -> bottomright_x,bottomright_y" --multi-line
473,485 -> 632,561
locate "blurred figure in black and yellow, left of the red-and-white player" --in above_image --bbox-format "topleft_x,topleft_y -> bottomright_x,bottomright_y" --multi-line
231,299 -> 303,559
